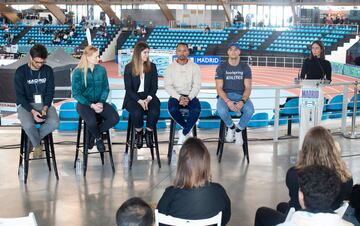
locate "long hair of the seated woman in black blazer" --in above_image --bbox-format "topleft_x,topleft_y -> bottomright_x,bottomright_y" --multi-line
130,42 -> 151,76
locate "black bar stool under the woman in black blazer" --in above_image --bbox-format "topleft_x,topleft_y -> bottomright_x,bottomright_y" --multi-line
125,113 -> 161,169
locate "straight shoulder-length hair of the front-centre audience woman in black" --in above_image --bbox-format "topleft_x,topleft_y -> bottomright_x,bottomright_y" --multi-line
174,138 -> 211,188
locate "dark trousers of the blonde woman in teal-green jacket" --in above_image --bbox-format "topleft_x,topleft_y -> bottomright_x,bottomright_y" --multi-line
76,103 -> 119,138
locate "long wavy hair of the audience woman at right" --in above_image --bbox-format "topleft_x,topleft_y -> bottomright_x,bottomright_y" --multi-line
296,126 -> 351,182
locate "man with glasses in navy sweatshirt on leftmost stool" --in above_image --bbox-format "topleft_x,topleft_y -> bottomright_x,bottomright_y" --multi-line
14,44 -> 59,157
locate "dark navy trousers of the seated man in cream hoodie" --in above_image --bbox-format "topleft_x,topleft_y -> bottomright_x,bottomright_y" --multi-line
168,97 -> 201,135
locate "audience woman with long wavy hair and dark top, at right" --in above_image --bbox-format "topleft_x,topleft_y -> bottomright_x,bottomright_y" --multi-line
255,126 -> 353,226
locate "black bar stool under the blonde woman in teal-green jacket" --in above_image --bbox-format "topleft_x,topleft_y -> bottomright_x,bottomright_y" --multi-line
74,115 -> 115,177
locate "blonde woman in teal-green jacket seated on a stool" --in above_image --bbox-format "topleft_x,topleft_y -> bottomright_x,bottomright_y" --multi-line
72,46 -> 119,152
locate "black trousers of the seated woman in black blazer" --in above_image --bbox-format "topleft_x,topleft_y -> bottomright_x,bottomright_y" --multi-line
125,98 -> 160,129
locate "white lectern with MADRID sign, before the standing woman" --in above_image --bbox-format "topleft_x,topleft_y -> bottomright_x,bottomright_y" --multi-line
298,79 -> 330,150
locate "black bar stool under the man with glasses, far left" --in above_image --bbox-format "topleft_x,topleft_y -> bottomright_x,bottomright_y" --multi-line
18,124 -> 59,184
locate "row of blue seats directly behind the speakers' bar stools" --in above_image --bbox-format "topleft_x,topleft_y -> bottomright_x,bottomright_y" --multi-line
58,94 -> 360,132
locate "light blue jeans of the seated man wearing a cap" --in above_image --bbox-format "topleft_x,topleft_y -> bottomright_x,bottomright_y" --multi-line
216,93 -> 254,130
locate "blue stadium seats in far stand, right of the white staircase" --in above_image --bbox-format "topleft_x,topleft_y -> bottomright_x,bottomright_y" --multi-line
121,25 -> 354,54
